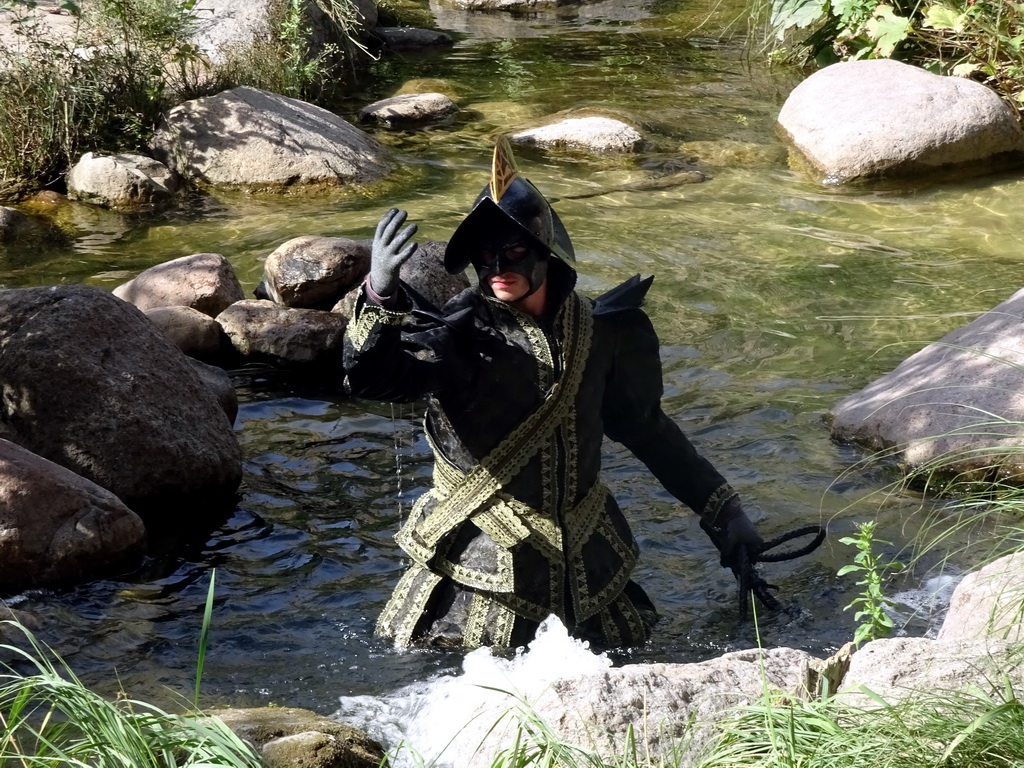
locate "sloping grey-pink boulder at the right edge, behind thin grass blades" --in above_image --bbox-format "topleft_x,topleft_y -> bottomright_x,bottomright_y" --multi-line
829,290 -> 1024,475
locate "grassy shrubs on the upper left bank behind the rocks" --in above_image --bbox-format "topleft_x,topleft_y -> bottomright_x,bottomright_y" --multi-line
0,0 -> 359,200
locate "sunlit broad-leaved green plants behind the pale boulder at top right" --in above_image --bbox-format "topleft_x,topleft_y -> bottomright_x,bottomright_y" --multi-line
765,0 -> 1024,112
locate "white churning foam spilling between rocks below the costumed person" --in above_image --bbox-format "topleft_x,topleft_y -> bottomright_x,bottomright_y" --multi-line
332,616 -> 611,768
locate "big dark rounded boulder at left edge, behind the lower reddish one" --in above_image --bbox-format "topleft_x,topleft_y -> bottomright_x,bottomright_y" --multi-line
0,286 -> 242,516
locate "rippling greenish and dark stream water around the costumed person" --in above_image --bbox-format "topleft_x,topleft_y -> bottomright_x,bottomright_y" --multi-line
0,0 -> 1024,745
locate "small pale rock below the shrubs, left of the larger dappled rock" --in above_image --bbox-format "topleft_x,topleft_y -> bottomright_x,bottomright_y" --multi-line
68,152 -> 178,210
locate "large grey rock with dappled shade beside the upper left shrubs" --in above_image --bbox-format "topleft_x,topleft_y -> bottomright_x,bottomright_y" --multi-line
151,86 -> 390,191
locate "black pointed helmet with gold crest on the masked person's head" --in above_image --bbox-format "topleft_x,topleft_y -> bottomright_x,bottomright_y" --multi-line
444,136 -> 575,274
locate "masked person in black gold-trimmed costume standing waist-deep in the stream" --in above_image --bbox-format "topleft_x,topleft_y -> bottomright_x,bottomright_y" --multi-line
344,140 -> 763,648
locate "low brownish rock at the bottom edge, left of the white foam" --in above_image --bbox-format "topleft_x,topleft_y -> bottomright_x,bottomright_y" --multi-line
209,707 -> 384,768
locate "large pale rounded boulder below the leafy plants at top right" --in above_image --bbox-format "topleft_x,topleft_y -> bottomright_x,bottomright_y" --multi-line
778,58 -> 1024,183
